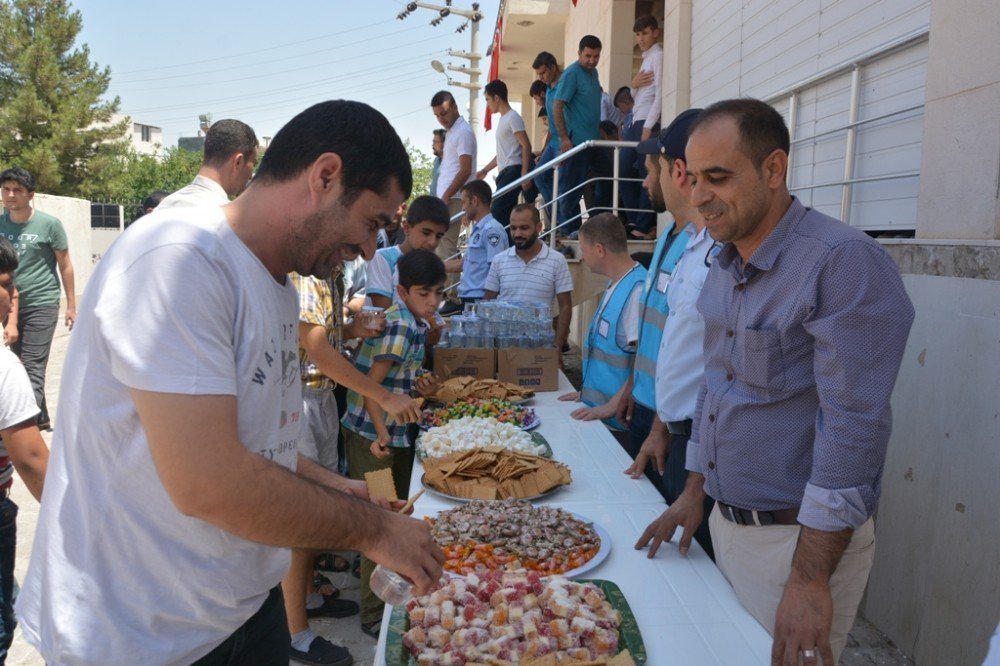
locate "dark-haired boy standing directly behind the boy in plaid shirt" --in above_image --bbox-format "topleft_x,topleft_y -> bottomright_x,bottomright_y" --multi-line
366,195 -> 451,308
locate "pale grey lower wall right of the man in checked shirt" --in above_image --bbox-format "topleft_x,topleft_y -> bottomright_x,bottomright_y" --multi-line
862,268 -> 1000,666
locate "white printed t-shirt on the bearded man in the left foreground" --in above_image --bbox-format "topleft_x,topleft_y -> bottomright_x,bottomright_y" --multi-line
17,206 -> 302,666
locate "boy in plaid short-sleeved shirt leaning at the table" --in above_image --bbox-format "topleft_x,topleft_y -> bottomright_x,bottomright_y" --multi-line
341,250 -> 447,638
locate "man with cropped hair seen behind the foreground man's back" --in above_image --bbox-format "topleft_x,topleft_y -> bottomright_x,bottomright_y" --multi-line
157,118 -> 257,209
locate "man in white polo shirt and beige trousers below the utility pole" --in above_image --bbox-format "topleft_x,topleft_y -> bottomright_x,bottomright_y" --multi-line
431,90 -> 476,268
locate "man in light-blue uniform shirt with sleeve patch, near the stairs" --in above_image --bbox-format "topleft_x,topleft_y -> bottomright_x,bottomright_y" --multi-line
441,180 -> 508,306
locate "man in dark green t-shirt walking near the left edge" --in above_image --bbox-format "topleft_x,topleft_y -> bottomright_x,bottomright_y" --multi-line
0,167 -> 76,429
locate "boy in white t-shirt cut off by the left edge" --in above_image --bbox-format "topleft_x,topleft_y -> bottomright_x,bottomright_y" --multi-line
0,236 -> 49,652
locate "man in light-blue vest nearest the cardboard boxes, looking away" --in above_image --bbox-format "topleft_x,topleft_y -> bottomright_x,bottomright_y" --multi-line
559,213 -> 646,435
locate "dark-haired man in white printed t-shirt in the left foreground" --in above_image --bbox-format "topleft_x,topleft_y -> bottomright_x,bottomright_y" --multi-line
17,100 -> 443,665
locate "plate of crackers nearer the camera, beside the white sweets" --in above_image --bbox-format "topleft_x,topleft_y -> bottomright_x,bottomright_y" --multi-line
421,446 -> 573,502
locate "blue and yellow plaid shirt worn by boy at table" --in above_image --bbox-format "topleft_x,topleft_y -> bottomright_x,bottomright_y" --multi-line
341,303 -> 427,448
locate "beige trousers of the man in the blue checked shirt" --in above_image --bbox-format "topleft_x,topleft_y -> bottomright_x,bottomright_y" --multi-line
708,505 -> 875,666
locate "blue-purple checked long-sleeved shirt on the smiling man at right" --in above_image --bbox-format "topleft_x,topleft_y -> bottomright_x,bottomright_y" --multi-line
687,199 -> 913,531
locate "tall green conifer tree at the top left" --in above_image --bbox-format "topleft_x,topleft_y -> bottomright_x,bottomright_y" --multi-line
0,0 -> 131,198
